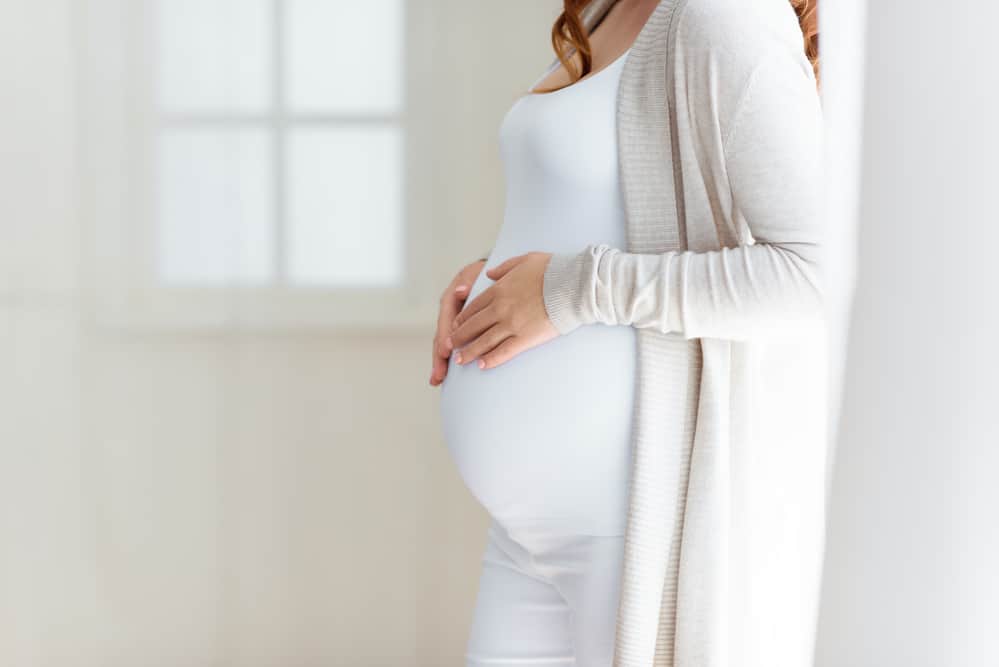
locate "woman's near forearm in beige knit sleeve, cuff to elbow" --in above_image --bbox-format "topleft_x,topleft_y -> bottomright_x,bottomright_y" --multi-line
543,244 -> 822,339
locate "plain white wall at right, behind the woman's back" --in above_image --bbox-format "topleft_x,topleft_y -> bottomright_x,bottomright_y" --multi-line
818,0 -> 999,667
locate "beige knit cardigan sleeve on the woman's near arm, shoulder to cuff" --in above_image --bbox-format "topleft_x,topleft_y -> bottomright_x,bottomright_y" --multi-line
543,50 -> 823,339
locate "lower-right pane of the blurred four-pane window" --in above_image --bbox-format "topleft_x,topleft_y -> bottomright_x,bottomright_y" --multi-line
288,126 -> 403,286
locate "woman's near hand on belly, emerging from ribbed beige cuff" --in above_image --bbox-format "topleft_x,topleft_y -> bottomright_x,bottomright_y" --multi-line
451,252 -> 559,368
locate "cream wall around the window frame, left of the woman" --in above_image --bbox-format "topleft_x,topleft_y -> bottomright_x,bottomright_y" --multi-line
0,0 -> 554,667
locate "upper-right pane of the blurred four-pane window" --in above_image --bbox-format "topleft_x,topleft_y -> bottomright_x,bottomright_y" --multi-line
285,0 -> 405,113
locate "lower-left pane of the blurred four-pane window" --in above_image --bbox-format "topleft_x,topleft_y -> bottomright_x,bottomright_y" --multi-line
157,128 -> 274,285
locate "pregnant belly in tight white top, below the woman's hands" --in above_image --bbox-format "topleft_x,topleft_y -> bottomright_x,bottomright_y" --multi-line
441,302 -> 636,535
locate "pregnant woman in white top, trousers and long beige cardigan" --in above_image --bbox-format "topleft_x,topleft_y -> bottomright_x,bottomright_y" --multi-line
430,0 -> 827,667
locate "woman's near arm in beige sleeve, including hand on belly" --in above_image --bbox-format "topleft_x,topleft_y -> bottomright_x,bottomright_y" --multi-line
450,41 -> 824,368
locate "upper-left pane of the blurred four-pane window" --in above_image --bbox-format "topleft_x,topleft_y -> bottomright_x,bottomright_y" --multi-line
156,0 -> 274,112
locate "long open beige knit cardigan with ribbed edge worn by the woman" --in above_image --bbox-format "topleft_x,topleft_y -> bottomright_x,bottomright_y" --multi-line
543,0 -> 828,667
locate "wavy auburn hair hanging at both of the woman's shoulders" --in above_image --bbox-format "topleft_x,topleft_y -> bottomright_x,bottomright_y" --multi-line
552,0 -> 819,90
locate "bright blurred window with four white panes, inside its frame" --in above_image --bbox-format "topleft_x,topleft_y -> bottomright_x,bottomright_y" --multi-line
152,0 -> 407,288
